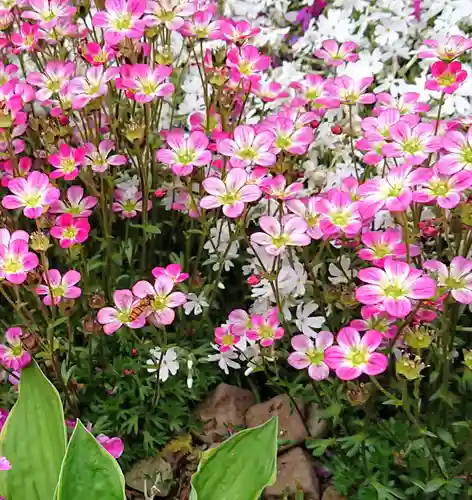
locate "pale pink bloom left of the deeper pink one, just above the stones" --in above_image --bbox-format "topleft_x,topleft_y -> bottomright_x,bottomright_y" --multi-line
287,331 -> 333,380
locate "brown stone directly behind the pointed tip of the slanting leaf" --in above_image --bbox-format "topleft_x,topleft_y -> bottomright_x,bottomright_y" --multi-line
246,394 -> 308,449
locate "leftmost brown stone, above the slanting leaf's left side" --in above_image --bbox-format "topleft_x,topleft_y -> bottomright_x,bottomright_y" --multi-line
197,384 -> 255,444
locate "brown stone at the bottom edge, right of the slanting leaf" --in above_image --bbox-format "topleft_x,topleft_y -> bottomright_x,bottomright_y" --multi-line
264,447 -> 320,500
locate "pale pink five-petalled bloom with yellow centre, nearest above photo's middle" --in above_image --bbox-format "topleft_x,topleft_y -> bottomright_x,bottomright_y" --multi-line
200,168 -> 262,218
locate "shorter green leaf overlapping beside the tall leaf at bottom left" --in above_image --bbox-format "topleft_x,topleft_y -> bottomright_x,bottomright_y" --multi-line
56,420 -> 125,500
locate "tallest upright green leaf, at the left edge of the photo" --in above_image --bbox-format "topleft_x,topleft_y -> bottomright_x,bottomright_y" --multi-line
0,361 -> 66,500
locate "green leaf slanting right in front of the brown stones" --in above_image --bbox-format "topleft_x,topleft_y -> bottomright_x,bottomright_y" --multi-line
190,417 -> 278,500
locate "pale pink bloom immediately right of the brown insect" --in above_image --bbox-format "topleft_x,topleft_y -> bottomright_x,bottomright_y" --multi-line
133,276 -> 187,325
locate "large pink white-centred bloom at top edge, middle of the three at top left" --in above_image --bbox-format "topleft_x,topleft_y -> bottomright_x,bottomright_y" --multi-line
92,0 -> 146,45
